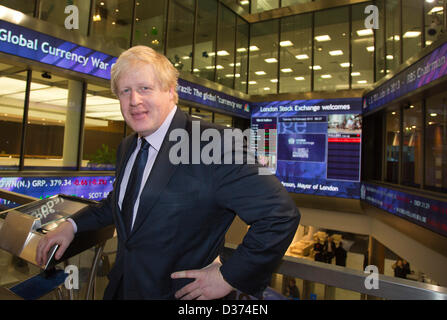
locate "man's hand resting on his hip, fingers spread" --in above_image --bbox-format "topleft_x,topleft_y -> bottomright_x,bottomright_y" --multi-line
171,259 -> 233,300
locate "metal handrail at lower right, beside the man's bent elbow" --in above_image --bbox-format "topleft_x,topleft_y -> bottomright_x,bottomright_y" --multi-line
224,243 -> 447,300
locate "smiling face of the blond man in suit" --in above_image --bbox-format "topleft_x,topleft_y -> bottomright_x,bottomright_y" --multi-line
117,63 -> 175,136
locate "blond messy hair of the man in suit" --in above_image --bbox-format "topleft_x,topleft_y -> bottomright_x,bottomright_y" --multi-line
110,46 -> 179,103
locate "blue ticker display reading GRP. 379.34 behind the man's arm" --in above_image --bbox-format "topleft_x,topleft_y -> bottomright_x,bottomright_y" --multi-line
0,176 -> 115,208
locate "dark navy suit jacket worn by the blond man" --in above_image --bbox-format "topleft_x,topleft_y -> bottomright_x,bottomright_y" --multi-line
72,108 -> 300,299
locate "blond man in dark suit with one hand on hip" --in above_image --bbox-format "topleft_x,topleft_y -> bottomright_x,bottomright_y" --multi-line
36,46 -> 300,299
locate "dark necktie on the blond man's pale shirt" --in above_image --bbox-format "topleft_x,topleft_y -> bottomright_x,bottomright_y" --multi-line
121,138 -> 150,234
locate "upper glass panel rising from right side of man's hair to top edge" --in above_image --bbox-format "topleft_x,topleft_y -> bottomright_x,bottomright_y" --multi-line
166,0 -> 195,72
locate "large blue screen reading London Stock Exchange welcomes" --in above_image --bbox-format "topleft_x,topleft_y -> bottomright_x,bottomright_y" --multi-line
251,98 -> 362,199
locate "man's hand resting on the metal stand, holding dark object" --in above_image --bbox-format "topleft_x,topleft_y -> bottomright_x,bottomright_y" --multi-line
36,221 -> 75,266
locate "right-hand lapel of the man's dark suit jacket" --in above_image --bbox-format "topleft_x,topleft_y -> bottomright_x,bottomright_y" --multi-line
130,108 -> 187,236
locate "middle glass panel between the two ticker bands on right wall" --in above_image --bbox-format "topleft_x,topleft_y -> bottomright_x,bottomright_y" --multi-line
402,103 -> 422,187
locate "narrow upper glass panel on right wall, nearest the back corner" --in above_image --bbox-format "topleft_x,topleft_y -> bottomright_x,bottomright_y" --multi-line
385,0 -> 401,73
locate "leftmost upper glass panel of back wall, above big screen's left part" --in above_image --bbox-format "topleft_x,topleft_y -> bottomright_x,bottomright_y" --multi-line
248,20 -> 280,94
